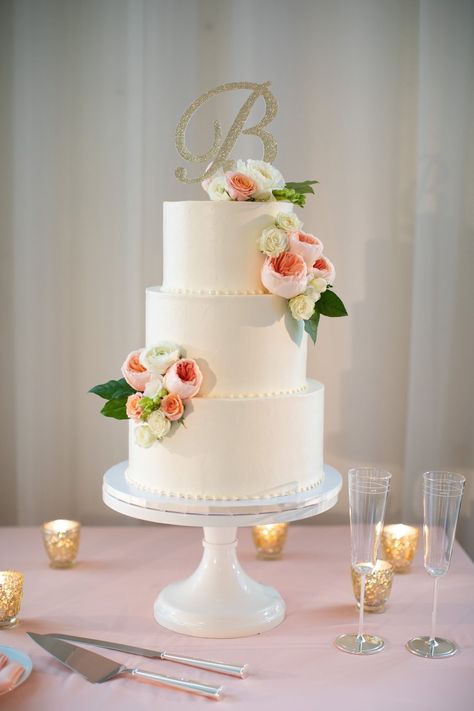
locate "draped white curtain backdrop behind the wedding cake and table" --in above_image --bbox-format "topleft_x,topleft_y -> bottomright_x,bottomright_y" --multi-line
0,0 -> 474,554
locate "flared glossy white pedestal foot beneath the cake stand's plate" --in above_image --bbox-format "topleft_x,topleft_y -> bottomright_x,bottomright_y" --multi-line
154,526 -> 285,638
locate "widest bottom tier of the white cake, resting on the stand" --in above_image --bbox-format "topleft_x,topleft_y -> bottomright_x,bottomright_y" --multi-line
126,380 -> 324,500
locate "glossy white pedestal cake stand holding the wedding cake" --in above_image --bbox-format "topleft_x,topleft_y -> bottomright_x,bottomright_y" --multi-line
103,462 -> 342,638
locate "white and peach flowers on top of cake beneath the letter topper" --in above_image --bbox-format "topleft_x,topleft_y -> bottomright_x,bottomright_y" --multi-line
202,159 -> 318,207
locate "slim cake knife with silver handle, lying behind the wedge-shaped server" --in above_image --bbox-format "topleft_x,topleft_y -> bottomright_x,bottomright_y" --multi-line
47,632 -> 248,679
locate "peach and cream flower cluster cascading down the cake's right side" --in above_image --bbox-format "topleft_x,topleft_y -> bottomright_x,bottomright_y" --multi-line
258,212 -> 347,342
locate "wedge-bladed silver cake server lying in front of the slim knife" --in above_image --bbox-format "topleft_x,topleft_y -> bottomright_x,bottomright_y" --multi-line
27,632 -> 222,701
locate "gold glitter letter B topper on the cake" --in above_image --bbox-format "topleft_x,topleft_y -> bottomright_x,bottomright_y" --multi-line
175,81 -> 278,183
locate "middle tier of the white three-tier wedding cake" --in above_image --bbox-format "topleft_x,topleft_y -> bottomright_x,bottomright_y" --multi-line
146,287 -> 307,397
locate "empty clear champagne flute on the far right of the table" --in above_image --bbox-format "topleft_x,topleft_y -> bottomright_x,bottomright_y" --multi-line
407,471 -> 466,659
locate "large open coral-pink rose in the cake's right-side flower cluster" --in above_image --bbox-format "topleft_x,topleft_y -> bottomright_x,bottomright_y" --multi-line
262,252 -> 308,299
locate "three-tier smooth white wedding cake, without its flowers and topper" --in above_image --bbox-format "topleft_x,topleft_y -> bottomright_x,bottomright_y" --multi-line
127,200 -> 324,500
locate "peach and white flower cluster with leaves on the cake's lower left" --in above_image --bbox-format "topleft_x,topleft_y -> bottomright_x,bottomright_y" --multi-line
89,341 -> 202,447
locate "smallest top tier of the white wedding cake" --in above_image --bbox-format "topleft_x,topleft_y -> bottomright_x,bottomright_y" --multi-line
162,201 -> 293,294
